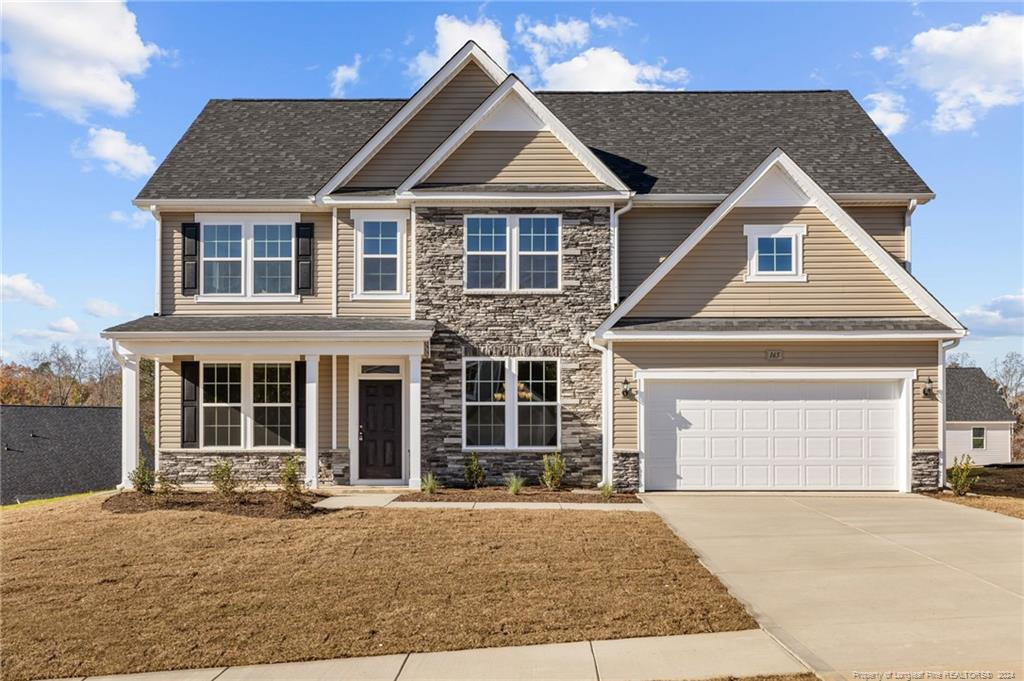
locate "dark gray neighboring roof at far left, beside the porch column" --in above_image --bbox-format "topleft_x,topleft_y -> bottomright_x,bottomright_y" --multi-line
0,405 -> 153,504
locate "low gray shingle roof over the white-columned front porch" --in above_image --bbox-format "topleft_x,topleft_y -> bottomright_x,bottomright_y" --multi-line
103,314 -> 435,334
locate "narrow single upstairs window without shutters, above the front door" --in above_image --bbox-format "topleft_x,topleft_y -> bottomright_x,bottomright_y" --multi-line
352,210 -> 409,299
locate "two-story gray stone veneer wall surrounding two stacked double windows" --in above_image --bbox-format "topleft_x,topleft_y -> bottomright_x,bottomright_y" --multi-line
416,206 -> 611,486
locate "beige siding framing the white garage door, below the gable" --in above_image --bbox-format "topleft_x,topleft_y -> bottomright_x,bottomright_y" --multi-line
612,341 -> 939,451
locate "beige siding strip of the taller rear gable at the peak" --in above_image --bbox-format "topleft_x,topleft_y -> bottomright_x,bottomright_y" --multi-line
346,61 -> 495,187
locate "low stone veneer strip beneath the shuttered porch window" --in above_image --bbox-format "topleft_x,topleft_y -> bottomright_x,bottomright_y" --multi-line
159,450 -> 331,484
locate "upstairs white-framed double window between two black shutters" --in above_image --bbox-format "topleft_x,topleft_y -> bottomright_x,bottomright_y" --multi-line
197,213 -> 299,301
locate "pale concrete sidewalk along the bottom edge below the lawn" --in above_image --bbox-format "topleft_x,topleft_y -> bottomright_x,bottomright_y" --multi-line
48,629 -> 807,681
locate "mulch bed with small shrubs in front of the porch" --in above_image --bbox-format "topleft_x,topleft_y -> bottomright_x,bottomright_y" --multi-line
102,492 -> 332,519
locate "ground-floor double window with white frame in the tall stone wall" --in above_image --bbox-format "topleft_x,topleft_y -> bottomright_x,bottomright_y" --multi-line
463,357 -> 561,450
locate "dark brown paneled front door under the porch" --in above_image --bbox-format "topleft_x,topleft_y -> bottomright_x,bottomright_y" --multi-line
359,381 -> 401,480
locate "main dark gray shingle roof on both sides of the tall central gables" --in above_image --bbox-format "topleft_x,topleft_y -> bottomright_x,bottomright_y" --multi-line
138,90 -> 930,200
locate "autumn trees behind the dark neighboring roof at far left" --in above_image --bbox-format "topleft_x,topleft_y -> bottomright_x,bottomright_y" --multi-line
0,343 -> 155,445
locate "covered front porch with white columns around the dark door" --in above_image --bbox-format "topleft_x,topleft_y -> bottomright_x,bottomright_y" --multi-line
105,315 -> 433,488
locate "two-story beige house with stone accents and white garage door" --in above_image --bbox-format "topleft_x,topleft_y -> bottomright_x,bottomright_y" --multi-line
104,43 -> 966,491
